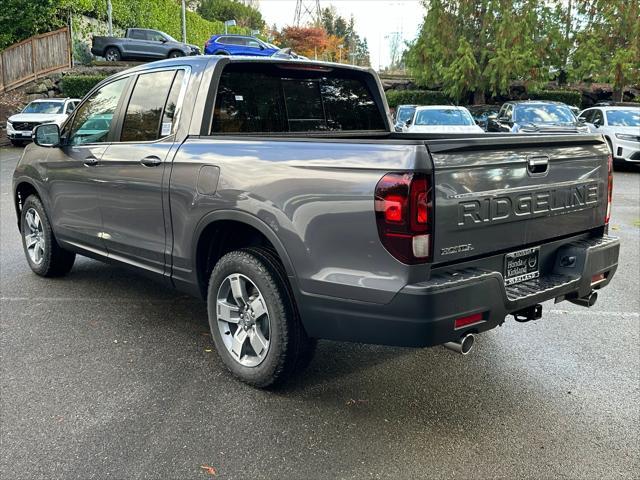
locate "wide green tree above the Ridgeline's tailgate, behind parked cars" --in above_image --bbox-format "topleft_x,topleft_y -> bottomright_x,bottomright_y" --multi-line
405,0 -> 549,103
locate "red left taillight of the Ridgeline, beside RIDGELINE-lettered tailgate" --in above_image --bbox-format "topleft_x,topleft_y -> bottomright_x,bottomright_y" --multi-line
375,173 -> 433,264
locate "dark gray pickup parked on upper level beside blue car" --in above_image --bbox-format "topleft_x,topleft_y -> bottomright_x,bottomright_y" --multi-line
91,28 -> 200,62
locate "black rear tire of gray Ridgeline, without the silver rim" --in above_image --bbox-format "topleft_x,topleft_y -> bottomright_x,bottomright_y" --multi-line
207,247 -> 316,388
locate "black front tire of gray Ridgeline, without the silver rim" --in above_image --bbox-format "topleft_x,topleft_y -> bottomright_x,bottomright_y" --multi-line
20,195 -> 76,277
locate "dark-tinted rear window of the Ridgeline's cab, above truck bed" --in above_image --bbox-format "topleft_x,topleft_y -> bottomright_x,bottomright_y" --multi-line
211,64 -> 386,134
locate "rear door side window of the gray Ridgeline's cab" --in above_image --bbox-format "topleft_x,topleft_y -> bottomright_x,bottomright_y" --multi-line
120,70 -> 184,142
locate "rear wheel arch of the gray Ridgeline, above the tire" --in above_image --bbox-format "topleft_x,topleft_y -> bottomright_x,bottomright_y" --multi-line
191,210 -> 298,298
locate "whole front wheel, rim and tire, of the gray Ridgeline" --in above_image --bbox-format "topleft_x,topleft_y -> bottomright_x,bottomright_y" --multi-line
20,195 -> 76,277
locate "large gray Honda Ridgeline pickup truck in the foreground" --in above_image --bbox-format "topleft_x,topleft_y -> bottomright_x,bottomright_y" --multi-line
13,56 -> 619,387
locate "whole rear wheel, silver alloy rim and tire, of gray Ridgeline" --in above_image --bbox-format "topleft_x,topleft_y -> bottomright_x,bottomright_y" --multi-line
207,247 -> 315,388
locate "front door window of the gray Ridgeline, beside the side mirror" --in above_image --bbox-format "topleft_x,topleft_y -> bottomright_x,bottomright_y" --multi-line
68,78 -> 128,145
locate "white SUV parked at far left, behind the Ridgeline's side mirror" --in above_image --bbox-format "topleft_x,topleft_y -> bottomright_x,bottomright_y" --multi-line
7,98 -> 80,146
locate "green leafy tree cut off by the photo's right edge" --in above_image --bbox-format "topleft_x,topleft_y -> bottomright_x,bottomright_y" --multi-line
570,0 -> 640,101
